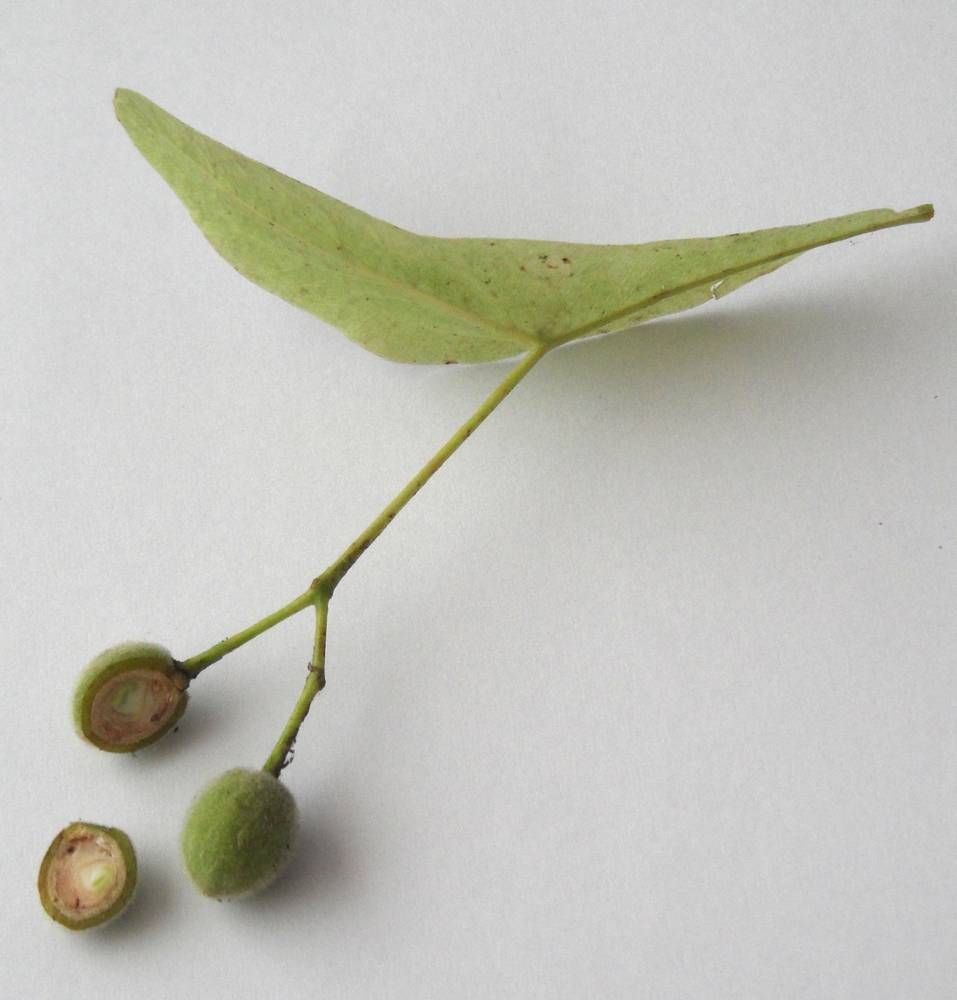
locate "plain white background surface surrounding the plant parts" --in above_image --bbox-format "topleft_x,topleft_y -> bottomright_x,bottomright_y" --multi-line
0,0 -> 957,1000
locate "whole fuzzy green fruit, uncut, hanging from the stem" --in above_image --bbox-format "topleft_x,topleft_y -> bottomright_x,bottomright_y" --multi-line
181,767 -> 298,899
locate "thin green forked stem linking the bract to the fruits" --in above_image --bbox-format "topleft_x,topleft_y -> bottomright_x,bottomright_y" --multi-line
182,344 -> 554,764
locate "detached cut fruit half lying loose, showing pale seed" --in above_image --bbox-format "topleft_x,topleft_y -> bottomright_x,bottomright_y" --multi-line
37,821 -> 136,931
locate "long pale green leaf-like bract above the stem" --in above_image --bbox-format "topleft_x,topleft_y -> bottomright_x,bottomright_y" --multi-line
115,90 -> 933,363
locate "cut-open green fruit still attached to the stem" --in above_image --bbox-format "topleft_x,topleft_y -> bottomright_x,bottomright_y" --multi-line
73,642 -> 190,753
